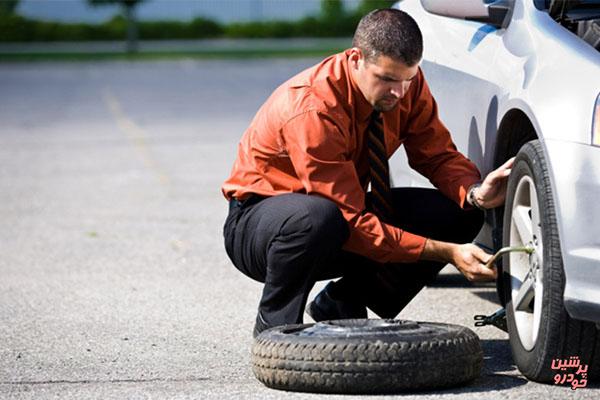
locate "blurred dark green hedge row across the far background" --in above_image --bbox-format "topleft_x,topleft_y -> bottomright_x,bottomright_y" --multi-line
0,0 -> 394,51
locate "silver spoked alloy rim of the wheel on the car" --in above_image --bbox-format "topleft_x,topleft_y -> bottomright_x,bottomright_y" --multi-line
509,176 -> 544,351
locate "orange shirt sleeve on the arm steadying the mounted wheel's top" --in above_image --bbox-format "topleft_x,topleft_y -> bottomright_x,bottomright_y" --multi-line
404,69 -> 481,208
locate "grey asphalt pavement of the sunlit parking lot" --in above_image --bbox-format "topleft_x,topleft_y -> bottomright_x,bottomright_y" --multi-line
0,59 -> 600,399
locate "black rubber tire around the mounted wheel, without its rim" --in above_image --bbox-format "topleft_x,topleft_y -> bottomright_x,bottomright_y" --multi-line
503,140 -> 600,382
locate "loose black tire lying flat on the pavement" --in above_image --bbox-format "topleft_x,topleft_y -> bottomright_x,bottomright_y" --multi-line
252,319 -> 483,394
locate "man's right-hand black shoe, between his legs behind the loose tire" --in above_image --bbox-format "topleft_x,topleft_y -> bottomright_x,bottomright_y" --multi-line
306,282 -> 367,322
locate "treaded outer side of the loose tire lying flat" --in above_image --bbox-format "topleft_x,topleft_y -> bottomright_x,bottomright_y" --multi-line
251,320 -> 483,393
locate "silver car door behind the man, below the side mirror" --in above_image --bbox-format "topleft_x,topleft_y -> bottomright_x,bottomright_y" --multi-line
390,0 -> 504,186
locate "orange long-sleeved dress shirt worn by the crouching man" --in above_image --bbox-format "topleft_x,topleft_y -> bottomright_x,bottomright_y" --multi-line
222,50 -> 480,263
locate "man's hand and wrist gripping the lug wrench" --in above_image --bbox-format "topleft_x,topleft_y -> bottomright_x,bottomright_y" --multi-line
421,239 -> 498,282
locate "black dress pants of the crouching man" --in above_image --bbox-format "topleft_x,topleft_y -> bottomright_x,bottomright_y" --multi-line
223,188 -> 483,326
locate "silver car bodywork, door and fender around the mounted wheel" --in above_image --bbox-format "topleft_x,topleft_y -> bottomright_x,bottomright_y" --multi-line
390,0 -> 600,321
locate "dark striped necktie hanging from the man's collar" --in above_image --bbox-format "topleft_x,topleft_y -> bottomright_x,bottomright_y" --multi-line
367,111 -> 394,222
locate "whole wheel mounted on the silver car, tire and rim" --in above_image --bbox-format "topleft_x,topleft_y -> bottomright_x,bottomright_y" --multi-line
503,140 -> 600,382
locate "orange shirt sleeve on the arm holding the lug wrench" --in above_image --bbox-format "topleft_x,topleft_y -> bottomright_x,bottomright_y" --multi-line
281,111 -> 426,263
